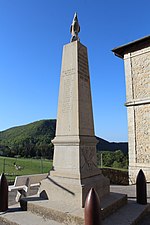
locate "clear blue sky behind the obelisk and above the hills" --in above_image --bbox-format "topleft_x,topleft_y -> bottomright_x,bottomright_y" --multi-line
0,0 -> 150,141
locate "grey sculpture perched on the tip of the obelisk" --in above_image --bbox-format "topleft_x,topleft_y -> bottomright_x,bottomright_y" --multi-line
70,13 -> 80,42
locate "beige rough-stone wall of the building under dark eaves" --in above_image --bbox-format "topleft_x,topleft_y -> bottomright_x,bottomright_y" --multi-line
124,47 -> 150,183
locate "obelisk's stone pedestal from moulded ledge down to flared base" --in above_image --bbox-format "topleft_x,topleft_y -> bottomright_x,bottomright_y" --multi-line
40,134 -> 109,208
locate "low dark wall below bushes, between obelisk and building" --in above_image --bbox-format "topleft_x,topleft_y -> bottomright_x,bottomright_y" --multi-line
101,168 -> 129,185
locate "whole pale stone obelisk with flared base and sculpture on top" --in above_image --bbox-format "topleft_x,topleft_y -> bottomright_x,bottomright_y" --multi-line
41,14 -> 109,207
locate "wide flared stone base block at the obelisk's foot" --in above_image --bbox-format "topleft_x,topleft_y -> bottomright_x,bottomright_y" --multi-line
40,174 -> 110,208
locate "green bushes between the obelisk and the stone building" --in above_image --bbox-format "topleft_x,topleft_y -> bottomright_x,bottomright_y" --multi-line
97,150 -> 128,169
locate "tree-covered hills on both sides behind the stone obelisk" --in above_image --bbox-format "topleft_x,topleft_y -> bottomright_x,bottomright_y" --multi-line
0,119 -> 128,158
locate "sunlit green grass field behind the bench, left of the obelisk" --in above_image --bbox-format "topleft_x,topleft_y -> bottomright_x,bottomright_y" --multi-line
0,157 -> 52,182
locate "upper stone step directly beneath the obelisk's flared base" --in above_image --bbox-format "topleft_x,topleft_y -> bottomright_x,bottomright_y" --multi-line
21,193 -> 127,225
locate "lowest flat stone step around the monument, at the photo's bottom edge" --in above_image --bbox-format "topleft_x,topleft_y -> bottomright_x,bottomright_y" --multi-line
0,201 -> 150,225
